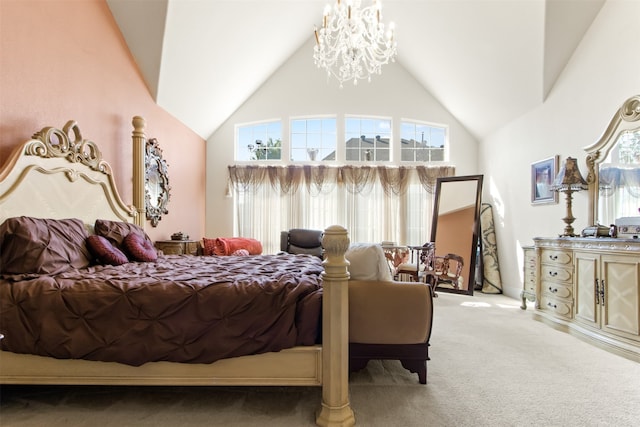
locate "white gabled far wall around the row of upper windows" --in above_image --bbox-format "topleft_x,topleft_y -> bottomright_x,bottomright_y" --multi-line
206,37 -> 478,247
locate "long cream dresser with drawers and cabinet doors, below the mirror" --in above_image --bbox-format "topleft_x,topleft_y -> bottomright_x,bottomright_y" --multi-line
523,237 -> 640,361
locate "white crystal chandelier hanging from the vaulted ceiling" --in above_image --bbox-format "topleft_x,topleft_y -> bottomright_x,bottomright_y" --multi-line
313,0 -> 396,87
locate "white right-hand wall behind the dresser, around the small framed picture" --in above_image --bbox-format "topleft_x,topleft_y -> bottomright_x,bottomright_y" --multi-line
480,0 -> 640,297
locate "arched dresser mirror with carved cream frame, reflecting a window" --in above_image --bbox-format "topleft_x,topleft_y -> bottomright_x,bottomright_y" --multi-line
585,95 -> 640,226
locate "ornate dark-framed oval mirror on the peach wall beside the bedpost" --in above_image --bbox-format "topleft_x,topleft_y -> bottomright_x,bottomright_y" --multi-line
144,138 -> 171,227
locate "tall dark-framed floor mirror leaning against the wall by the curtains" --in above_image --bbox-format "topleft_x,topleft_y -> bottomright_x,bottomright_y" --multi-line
431,175 -> 483,295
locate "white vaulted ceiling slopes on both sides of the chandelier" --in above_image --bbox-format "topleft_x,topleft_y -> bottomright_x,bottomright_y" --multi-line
107,0 -> 605,139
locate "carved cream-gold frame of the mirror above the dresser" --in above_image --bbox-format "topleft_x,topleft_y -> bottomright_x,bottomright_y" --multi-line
584,95 -> 640,225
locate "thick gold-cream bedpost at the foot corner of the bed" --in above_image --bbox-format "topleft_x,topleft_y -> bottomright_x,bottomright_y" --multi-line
316,225 -> 356,427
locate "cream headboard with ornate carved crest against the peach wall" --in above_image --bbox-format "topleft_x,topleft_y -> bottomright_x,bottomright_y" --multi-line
0,119 -> 144,231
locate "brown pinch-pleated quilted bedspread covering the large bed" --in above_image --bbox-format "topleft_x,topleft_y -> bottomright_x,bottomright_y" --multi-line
0,255 -> 323,366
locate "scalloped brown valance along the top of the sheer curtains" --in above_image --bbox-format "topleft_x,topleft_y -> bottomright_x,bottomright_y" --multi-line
229,165 -> 455,195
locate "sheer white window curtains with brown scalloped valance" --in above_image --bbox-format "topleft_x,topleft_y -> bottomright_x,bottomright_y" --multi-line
229,165 -> 455,253
